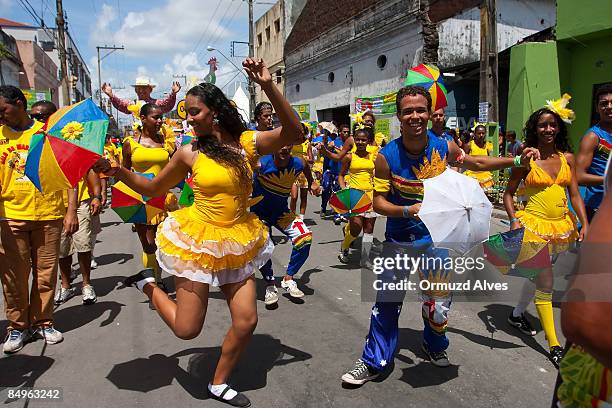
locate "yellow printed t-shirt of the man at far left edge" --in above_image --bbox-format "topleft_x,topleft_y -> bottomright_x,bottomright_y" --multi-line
0,122 -> 65,221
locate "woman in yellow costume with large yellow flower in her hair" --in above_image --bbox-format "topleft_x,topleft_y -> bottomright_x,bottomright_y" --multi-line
504,95 -> 589,367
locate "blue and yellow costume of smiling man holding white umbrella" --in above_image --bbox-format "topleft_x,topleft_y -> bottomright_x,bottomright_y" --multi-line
361,135 -> 451,371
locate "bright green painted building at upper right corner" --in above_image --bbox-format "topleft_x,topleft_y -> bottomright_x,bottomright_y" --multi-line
507,0 -> 612,150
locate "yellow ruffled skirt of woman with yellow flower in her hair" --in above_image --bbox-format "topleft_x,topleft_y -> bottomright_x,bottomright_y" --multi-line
515,211 -> 578,255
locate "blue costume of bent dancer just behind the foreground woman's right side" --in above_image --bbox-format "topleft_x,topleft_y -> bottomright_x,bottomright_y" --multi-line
251,155 -> 312,282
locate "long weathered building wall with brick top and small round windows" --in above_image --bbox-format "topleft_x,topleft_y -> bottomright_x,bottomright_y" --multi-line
285,1 -> 422,136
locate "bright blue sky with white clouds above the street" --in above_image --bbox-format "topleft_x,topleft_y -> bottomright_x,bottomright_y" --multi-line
0,0 -> 274,123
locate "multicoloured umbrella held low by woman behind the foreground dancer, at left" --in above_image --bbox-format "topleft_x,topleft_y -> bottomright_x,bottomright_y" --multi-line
111,173 -> 166,224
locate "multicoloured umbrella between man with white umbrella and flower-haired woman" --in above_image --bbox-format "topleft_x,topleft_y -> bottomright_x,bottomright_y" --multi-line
482,228 -> 551,279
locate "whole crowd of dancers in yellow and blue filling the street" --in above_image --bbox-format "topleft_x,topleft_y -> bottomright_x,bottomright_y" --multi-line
0,55 -> 612,406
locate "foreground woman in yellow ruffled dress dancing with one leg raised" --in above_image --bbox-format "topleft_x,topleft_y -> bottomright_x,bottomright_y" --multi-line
96,58 -> 302,406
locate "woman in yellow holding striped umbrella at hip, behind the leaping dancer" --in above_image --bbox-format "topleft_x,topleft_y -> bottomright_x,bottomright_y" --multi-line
122,103 -> 176,290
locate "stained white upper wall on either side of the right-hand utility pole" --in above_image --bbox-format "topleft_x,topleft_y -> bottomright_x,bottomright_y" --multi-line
438,0 -> 555,68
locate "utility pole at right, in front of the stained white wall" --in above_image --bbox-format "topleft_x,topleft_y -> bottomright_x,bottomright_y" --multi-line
479,0 -> 499,124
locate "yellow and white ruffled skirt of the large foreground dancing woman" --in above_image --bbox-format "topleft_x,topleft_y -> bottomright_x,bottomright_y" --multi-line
156,207 -> 274,286
